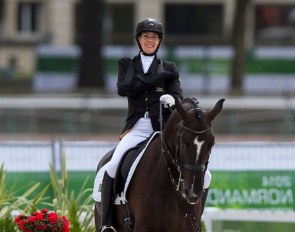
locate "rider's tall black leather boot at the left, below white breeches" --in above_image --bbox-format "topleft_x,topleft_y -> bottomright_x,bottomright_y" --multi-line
99,172 -> 116,232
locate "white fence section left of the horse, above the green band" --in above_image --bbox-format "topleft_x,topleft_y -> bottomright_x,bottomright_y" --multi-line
0,141 -> 115,172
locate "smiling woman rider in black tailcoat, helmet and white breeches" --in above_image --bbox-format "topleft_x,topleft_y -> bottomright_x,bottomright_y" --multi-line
100,18 -> 183,232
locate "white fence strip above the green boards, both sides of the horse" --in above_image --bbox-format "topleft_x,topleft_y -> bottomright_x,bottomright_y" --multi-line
0,140 -> 295,172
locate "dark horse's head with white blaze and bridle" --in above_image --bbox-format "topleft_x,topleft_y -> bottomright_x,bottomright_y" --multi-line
175,98 -> 224,204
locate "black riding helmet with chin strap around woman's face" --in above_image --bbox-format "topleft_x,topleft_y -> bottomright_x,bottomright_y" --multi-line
135,18 -> 164,56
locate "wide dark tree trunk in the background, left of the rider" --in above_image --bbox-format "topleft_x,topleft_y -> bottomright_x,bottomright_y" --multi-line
78,0 -> 105,89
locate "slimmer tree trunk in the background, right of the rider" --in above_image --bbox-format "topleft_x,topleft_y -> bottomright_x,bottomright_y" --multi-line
231,0 -> 251,95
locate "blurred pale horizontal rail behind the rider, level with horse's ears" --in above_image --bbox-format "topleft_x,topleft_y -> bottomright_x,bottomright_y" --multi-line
0,95 -> 295,110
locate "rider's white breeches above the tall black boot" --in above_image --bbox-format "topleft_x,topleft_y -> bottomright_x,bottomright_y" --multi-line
106,118 -> 154,178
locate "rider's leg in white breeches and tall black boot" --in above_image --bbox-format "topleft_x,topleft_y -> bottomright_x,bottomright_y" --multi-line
100,119 -> 153,232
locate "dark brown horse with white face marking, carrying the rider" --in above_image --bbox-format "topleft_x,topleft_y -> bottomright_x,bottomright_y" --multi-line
95,98 -> 224,232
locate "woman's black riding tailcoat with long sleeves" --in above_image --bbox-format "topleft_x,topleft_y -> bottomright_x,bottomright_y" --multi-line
117,55 -> 183,133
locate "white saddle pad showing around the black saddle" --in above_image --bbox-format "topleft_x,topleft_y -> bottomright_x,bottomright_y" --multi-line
92,131 -> 161,205
